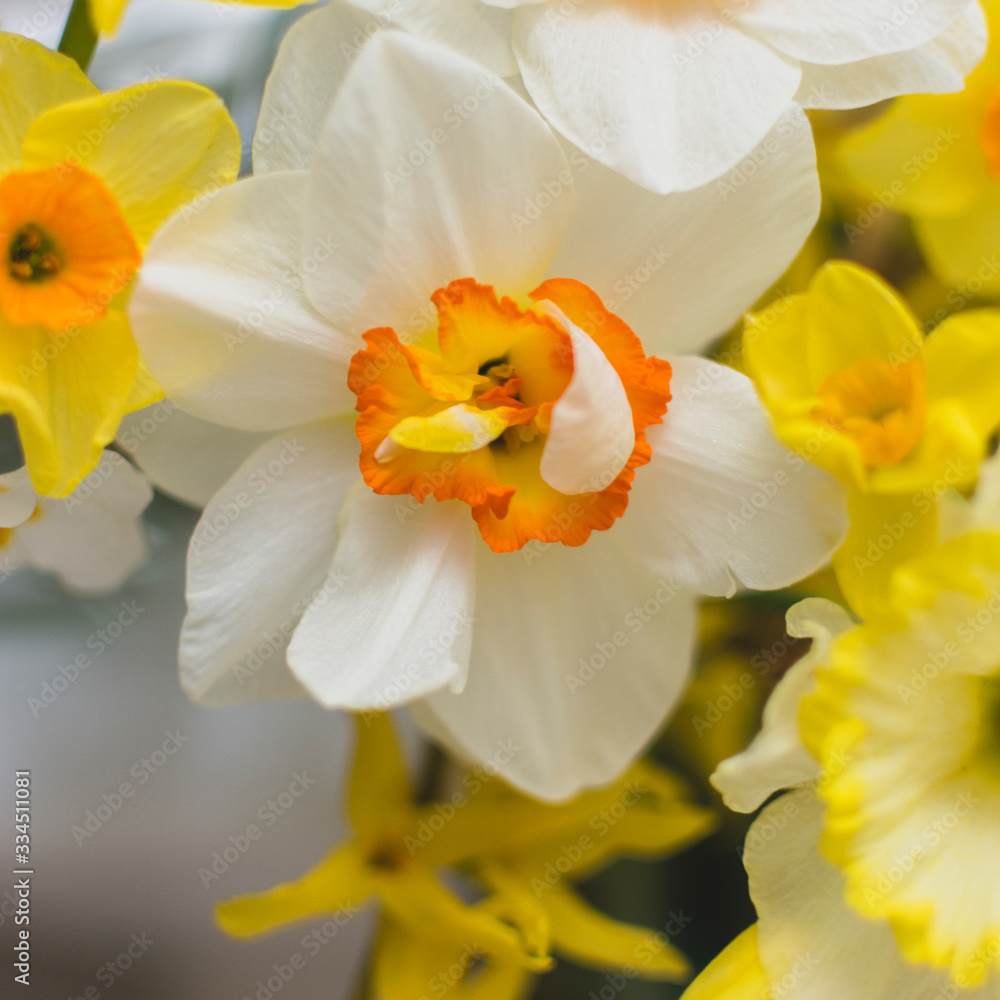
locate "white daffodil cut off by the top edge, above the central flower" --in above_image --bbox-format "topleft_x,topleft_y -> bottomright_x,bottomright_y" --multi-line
331,0 -> 986,193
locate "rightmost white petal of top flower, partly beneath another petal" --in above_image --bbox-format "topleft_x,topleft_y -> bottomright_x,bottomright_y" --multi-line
795,3 -> 986,109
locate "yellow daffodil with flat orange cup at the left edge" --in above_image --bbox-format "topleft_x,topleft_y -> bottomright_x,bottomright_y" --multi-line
0,34 -> 240,497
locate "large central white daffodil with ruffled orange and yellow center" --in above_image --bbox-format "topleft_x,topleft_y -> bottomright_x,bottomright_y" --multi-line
131,31 -> 845,798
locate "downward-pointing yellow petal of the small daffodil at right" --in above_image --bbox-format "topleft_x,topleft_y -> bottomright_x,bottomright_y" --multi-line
833,490 -> 938,618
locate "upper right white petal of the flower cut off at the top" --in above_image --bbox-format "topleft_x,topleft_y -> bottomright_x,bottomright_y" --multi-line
737,0 -> 969,64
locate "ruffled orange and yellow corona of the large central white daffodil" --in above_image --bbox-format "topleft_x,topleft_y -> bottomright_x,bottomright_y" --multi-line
348,278 -> 670,552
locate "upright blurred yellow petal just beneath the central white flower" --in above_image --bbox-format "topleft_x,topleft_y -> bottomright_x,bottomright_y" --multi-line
347,712 -> 413,840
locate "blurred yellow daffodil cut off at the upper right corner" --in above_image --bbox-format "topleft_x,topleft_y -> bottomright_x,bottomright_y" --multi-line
837,0 -> 1000,300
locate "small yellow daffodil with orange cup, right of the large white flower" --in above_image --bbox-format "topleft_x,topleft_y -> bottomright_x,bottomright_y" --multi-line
744,261 -> 1000,614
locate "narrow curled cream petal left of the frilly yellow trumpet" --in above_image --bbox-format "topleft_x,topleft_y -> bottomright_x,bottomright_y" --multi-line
711,597 -> 852,812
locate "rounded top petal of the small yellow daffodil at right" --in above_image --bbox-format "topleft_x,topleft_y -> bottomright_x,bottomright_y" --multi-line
806,260 -> 923,388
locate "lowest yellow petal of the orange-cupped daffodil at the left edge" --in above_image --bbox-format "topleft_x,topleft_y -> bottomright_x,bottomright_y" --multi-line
0,309 -> 139,497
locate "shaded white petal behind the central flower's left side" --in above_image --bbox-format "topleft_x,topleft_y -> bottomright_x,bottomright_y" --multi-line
116,399 -> 268,507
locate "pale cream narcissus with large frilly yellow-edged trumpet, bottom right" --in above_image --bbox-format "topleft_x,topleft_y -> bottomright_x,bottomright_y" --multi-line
689,524 -> 1000,1000
